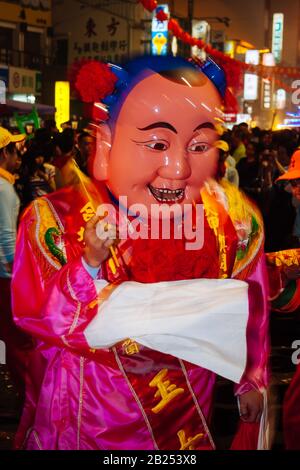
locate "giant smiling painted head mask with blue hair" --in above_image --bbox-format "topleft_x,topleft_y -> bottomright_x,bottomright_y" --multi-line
93,58 -> 224,210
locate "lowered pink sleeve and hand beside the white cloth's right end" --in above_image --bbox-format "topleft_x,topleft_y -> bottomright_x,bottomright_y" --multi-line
235,254 -> 269,395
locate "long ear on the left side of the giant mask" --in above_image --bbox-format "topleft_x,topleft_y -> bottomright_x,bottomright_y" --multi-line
91,124 -> 111,181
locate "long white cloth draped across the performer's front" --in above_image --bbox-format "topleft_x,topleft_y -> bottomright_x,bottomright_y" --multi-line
85,279 -> 248,383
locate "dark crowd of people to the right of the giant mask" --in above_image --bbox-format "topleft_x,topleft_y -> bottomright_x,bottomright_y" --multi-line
219,123 -> 300,252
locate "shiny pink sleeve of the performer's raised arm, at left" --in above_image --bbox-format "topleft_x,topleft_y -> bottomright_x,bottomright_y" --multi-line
12,207 -> 96,351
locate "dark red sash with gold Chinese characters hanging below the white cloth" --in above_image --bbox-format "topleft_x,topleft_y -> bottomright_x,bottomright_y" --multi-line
113,340 -> 215,450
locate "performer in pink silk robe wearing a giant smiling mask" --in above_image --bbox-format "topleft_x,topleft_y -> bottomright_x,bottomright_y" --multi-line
13,57 -> 268,450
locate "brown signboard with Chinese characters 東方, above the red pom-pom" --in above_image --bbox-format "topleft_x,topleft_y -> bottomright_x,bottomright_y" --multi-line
69,12 -> 129,64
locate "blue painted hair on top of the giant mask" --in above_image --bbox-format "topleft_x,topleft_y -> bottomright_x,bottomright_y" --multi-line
102,56 -> 226,131
